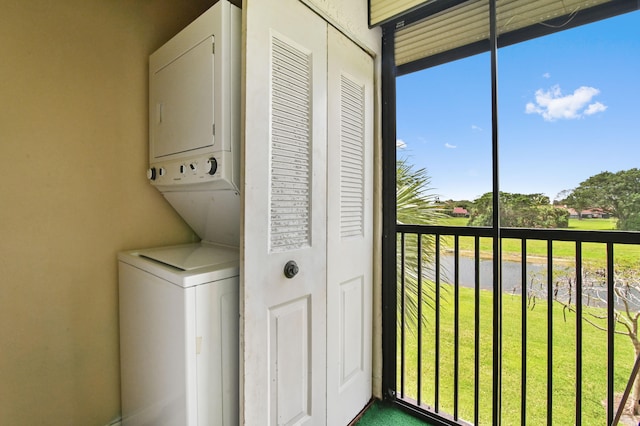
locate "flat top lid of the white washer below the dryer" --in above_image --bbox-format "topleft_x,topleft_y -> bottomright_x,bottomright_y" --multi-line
138,244 -> 238,271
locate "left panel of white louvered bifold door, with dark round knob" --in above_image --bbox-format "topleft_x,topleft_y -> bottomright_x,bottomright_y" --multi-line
241,0 -> 327,426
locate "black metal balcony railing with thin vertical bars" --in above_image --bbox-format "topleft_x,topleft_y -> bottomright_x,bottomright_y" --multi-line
394,225 -> 640,425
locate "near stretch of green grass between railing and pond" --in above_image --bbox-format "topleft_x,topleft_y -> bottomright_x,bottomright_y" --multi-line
398,288 -> 634,425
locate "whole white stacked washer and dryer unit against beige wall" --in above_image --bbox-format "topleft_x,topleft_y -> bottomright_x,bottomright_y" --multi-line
118,0 -> 241,426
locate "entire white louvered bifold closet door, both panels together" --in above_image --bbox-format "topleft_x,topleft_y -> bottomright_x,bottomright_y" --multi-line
241,0 -> 373,426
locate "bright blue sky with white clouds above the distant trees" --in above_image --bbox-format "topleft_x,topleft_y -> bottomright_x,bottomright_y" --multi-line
397,12 -> 640,200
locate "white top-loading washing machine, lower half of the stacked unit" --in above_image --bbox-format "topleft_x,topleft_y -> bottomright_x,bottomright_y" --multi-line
118,243 -> 239,426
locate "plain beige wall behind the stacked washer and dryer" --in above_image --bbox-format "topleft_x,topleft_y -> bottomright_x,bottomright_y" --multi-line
0,0 -> 214,426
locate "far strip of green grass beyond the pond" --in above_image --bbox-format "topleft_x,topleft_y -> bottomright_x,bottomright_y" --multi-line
442,217 -> 640,269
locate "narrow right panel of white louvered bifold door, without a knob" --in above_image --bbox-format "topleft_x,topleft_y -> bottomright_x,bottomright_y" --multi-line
327,27 -> 374,425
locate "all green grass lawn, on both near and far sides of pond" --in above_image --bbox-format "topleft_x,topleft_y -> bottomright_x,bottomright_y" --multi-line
398,218 -> 640,425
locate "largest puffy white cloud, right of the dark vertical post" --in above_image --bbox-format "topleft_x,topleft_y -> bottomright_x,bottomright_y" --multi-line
525,85 -> 607,121
